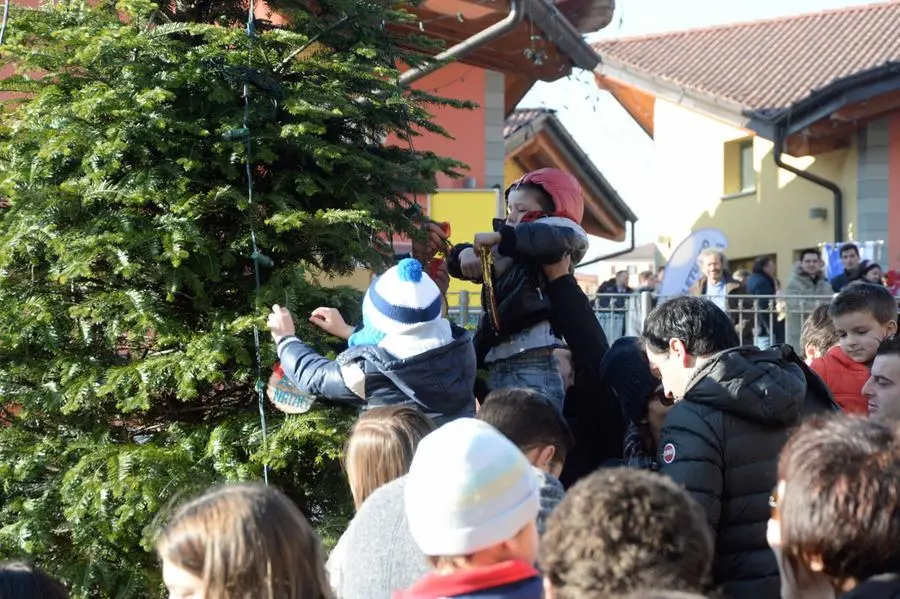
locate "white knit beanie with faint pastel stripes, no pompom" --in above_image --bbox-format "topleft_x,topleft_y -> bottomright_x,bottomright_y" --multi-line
405,418 -> 540,557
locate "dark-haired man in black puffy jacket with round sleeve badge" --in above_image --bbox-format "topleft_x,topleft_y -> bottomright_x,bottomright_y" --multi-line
643,297 -> 831,599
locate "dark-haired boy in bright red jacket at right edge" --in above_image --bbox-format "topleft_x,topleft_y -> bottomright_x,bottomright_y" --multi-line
810,283 -> 897,414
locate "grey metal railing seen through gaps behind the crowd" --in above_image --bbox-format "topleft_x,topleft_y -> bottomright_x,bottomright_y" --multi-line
447,291 -> 833,349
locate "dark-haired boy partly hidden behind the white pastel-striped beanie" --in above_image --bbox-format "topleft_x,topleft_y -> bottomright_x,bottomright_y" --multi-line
478,387 -> 574,534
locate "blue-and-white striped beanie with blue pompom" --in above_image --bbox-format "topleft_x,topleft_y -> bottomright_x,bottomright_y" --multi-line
348,258 -> 442,347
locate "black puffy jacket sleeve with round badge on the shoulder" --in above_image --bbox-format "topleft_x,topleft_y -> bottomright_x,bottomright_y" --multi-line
657,401 -> 725,531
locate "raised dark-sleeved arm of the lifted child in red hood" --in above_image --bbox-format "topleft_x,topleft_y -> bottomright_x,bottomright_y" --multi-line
497,217 -> 589,264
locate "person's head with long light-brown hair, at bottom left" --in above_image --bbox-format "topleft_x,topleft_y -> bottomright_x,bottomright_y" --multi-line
156,484 -> 332,599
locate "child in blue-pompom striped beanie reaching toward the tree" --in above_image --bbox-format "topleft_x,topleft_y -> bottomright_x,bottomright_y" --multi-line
268,259 -> 475,424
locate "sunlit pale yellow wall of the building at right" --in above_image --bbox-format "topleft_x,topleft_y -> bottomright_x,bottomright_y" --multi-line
653,100 -> 857,284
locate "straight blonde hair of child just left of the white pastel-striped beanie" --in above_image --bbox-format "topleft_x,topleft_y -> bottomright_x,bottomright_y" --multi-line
344,405 -> 435,510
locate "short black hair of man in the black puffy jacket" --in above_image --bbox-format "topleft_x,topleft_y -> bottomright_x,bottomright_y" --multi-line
641,297 -> 741,357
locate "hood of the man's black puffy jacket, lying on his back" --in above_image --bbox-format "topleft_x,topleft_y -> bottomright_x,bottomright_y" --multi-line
686,347 -> 806,426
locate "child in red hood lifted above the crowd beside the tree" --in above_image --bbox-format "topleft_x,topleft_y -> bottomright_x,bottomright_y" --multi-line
447,169 -> 588,411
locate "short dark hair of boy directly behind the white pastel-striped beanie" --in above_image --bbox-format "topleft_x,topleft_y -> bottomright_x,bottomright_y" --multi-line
478,387 -> 575,463
